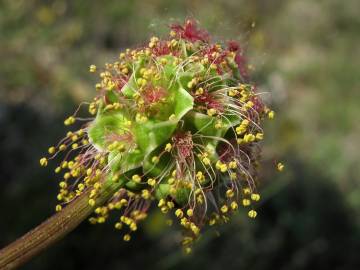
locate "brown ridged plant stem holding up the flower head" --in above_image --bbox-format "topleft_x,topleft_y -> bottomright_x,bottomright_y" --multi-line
0,180 -> 121,270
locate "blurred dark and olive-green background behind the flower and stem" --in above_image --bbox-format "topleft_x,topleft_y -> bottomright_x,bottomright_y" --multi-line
0,0 -> 360,270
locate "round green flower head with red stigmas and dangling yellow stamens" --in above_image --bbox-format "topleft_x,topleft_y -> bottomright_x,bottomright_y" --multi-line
40,20 -> 283,251
